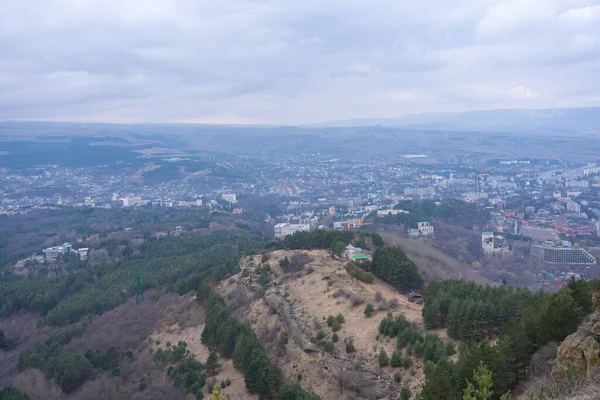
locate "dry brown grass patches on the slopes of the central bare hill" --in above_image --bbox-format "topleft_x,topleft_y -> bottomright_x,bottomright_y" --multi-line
220,250 -> 432,399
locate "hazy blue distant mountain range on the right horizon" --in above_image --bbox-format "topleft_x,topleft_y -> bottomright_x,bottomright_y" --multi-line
309,107 -> 600,132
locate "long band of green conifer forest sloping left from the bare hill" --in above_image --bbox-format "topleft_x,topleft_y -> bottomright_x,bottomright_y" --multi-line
0,232 -> 264,325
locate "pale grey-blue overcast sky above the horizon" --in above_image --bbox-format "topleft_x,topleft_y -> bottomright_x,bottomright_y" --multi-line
0,0 -> 600,124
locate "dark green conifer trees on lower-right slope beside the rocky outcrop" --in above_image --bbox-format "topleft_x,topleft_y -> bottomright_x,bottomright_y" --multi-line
421,280 -> 597,400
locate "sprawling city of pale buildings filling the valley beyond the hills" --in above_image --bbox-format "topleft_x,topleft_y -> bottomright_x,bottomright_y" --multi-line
0,151 -> 600,276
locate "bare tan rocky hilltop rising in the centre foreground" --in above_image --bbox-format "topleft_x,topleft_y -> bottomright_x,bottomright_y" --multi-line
218,250 -> 424,400
